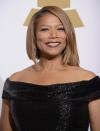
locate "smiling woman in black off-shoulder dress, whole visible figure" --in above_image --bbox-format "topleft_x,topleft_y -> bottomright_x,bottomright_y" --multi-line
1,6 -> 100,131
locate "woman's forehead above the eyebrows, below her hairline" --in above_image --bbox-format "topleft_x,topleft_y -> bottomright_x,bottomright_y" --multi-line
36,13 -> 62,25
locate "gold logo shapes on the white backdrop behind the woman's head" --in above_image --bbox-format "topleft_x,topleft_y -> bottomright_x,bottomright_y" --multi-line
24,0 -> 83,27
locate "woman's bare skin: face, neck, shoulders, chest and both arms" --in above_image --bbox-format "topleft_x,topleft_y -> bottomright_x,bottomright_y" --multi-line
0,13 -> 100,131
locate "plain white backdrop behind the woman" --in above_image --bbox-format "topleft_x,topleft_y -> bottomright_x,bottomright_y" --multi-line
0,0 -> 100,127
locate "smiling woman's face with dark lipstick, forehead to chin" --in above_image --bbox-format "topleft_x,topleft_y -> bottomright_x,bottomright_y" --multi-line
36,13 -> 66,57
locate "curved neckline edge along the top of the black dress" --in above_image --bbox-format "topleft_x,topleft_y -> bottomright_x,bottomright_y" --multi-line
7,76 -> 99,87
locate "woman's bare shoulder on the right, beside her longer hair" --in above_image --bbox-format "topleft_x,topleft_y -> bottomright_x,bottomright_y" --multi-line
73,67 -> 96,80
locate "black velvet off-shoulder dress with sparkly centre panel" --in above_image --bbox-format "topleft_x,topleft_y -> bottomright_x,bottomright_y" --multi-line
2,76 -> 100,131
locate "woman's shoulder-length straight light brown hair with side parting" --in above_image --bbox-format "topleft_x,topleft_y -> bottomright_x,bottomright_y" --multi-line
26,6 -> 79,66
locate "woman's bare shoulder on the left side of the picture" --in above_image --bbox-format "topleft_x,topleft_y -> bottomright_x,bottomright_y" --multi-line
9,66 -> 31,81
